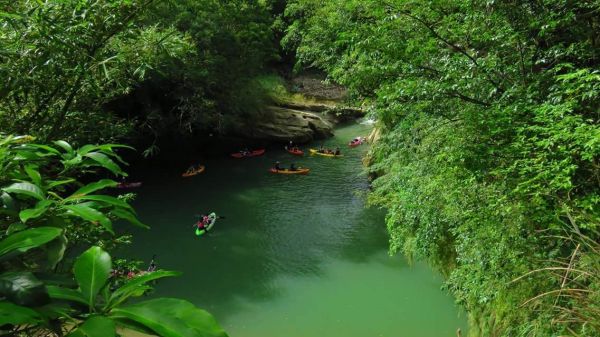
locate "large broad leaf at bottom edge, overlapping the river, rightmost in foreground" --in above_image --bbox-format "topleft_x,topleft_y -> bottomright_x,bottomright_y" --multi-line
111,298 -> 227,337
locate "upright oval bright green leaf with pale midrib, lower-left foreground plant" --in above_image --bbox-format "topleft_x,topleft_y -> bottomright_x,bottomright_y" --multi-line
73,246 -> 112,308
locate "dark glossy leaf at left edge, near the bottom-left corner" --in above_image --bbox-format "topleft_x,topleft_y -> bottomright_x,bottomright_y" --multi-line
0,272 -> 48,306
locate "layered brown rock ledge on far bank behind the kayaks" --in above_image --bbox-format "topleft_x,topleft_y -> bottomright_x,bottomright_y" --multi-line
237,107 -> 333,143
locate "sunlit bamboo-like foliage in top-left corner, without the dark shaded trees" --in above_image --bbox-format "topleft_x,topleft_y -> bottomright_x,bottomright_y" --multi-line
0,0 -> 193,141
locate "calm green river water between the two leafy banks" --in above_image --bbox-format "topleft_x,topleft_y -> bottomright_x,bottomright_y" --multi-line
126,123 -> 466,337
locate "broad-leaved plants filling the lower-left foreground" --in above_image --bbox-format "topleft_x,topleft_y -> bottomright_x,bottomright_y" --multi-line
0,136 -> 226,337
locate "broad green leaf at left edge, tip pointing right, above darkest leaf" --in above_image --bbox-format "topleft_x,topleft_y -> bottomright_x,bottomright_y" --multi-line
0,227 -> 62,256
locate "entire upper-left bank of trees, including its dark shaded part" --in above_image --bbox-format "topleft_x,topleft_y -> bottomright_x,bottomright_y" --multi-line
0,0 -> 280,146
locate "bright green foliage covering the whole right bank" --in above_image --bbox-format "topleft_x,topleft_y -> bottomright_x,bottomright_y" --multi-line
282,0 -> 600,336
